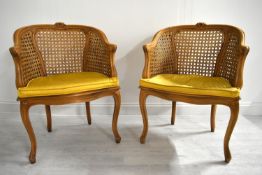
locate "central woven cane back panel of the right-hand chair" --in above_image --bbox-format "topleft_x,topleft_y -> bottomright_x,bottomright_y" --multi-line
174,30 -> 224,76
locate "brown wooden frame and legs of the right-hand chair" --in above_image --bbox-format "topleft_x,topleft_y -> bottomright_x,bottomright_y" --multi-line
139,23 -> 249,163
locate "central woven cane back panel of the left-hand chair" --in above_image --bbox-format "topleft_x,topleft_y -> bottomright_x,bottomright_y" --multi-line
36,30 -> 86,75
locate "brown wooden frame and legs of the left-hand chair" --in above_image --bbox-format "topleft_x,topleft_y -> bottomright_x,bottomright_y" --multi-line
10,23 -> 121,163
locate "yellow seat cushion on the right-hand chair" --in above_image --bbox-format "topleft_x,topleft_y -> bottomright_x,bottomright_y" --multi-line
140,74 -> 240,98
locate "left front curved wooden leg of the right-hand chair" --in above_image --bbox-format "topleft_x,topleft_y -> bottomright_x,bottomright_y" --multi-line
139,90 -> 148,144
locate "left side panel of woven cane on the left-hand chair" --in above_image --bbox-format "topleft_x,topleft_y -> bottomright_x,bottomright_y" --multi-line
20,31 -> 43,85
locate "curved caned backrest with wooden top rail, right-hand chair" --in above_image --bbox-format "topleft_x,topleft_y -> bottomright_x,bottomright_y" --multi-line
148,23 -> 248,85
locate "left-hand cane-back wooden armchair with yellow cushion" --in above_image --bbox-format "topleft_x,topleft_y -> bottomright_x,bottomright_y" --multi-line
10,23 -> 121,163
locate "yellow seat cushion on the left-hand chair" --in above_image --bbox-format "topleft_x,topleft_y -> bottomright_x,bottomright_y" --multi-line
18,72 -> 119,98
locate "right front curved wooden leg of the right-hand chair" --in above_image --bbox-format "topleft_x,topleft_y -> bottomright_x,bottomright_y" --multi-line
224,102 -> 239,163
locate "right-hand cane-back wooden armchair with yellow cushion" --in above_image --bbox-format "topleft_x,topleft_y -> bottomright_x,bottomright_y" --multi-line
140,23 -> 249,162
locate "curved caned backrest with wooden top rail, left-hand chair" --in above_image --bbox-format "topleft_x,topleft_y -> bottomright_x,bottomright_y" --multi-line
11,23 -> 112,85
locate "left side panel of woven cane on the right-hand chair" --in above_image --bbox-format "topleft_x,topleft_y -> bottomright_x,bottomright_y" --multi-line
149,32 -> 176,76
